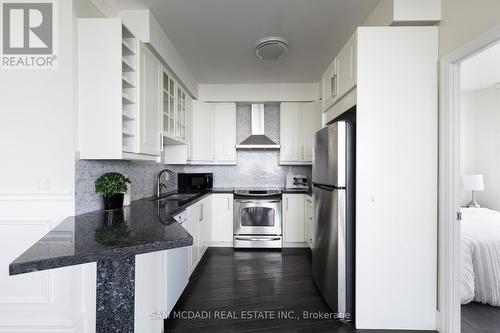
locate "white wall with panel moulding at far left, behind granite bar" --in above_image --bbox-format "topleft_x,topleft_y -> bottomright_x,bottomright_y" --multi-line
0,1 -> 84,333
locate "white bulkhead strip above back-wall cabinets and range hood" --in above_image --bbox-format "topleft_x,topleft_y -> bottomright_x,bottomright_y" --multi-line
198,83 -> 320,102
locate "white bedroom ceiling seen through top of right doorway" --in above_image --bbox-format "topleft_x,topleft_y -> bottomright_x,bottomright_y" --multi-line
462,43 -> 500,90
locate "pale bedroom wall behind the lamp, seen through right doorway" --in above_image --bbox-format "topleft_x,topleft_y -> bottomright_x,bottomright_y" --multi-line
460,87 -> 500,211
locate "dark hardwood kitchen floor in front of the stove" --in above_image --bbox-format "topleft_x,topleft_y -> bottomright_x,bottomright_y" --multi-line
165,248 -> 436,333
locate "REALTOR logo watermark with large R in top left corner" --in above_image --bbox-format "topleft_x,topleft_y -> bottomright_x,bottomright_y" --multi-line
0,0 -> 57,69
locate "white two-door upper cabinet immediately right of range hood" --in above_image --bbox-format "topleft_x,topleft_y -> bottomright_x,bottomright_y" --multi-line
280,102 -> 321,165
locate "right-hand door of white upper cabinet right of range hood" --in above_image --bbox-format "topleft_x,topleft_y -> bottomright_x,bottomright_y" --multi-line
300,102 -> 321,163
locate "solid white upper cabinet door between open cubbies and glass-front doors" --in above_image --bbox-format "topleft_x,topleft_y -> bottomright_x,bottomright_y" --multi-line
140,45 -> 163,155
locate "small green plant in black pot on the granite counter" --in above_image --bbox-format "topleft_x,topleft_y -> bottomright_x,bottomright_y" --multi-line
95,172 -> 130,210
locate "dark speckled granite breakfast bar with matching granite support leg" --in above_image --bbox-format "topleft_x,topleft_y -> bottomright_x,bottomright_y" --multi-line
9,192 -> 211,333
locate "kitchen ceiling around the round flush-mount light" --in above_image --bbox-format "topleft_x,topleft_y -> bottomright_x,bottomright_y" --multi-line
107,0 -> 378,83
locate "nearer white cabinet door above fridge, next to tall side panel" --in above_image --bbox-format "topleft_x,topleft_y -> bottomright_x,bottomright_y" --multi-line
336,35 -> 356,99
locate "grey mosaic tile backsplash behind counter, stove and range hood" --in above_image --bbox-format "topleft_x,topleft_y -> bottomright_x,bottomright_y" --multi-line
75,104 -> 312,214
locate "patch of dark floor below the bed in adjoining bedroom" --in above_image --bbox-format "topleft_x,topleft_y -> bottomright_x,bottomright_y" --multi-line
462,302 -> 500,333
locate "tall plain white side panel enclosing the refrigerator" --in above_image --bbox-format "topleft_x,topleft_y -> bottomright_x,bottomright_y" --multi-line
356,27 -> 438,330
